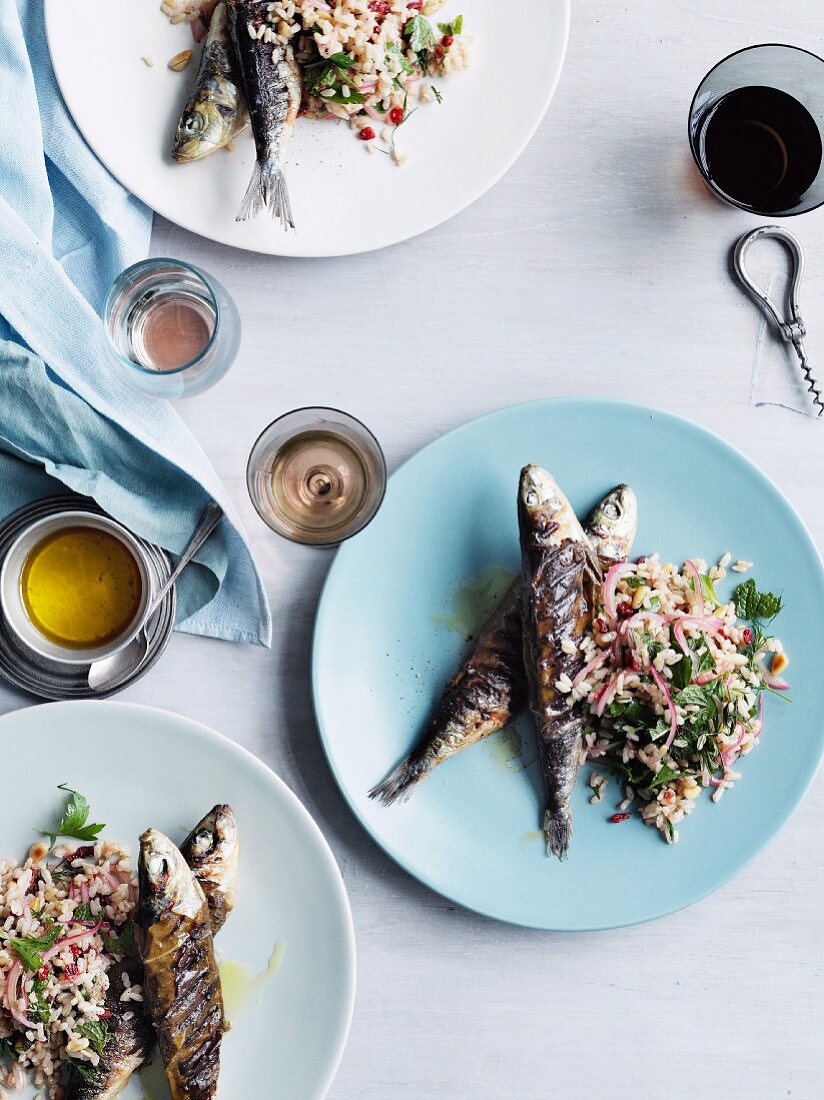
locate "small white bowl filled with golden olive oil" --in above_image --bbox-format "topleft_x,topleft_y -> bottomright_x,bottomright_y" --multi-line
0,512 -> 153,664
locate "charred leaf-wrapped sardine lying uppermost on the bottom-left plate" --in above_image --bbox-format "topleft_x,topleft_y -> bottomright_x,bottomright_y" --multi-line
135,828 -> 226,1100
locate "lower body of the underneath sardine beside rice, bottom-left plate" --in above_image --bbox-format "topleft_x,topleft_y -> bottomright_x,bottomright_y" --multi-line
65,958 -> 154,1100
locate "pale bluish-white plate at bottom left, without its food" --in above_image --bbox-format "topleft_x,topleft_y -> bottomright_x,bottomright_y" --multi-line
0,701 -> 354,1100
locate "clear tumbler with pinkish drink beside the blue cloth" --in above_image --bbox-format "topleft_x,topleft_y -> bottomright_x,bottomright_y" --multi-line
103,256 -> 240,398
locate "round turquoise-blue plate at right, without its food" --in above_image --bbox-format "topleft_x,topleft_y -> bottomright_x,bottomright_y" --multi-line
312,399 -> 824,931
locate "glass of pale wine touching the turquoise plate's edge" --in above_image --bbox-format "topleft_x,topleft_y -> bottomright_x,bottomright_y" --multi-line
246,408 -> 386,546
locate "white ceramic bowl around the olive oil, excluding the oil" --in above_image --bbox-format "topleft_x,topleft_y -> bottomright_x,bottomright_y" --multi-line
0,512 -> 154,664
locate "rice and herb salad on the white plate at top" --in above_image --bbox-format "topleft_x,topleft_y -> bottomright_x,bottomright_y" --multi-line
161,0 -> 471,164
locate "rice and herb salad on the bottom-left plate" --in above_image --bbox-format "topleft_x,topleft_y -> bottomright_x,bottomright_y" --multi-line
0,792 -> 143,1100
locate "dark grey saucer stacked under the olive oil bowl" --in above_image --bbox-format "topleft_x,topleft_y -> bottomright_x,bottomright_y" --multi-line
0,494 -> 175,699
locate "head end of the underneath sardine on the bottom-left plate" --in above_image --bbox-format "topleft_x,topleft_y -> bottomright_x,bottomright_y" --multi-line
180,803 -> 239,936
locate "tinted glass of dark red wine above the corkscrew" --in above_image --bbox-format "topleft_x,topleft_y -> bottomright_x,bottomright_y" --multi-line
689,45 -> 824,218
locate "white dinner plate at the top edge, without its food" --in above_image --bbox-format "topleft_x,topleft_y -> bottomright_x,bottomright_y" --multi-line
45,0 -> 570,256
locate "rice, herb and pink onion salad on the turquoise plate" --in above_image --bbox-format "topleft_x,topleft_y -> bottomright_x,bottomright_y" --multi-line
558,554 -> 789,844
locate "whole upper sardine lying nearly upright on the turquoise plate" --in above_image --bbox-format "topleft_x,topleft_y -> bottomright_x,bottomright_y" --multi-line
518,465 -> 601,859
